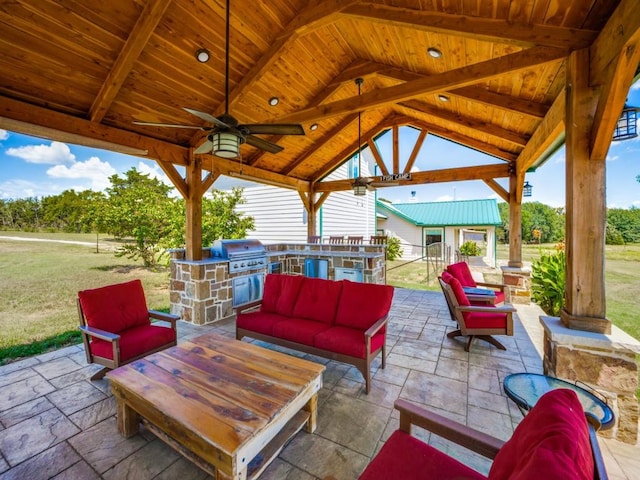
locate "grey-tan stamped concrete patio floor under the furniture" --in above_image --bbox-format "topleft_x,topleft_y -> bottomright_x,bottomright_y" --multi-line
0,289 -> 640,480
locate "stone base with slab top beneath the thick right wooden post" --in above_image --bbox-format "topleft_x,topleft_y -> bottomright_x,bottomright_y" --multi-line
540,316 -> 640,445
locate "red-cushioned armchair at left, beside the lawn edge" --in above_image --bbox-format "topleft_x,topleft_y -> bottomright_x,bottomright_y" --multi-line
78,280 -> 180,380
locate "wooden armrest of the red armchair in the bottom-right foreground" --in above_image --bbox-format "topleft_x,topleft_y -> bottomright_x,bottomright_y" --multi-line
394,399 -> 505,459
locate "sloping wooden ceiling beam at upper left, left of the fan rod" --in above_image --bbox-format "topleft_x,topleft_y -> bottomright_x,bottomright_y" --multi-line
89,0 -> 173,122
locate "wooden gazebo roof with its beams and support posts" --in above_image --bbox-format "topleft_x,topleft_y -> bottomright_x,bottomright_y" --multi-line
0,0 -> 640,342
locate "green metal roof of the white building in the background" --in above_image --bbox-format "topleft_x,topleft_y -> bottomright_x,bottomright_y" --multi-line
376,199 -> 502,227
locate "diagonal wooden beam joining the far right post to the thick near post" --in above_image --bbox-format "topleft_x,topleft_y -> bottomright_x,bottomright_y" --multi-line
516,90 -> 566,175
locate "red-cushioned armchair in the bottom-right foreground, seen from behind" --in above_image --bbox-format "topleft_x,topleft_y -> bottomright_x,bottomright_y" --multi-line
359,389 -> 607,480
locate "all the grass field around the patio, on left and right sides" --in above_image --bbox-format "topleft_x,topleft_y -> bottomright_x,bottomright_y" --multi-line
0,231 -> 640,360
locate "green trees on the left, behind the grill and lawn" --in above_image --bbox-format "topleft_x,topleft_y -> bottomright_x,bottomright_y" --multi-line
0,168 -> 254,266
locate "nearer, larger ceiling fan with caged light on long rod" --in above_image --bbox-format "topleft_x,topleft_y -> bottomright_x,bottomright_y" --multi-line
133,0 -> 305,158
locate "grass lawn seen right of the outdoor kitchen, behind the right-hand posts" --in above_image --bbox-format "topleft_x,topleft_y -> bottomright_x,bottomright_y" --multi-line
387,244 -> 640,340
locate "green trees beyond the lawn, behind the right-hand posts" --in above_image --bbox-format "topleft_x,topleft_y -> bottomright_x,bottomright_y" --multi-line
496,202 -> 640,245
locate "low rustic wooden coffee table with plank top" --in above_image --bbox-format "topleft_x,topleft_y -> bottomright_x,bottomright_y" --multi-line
107,334 -> 324,480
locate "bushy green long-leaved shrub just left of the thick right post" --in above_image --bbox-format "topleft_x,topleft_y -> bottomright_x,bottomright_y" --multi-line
531,250 -> 566,316
